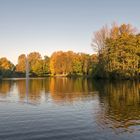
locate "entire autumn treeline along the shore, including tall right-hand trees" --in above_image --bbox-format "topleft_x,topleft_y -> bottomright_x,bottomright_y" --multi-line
0,23 -> 140,79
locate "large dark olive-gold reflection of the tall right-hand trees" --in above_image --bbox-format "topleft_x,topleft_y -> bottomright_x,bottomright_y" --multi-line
97,81 -> 140,132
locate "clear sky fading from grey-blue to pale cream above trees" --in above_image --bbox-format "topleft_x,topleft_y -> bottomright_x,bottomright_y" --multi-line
0,0 -> 140,64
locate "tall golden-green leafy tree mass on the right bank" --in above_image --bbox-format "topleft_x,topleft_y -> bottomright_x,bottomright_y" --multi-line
92,24 -> 140,78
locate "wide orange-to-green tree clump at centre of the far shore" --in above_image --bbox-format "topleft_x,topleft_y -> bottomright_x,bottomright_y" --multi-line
50,51 -> 96,75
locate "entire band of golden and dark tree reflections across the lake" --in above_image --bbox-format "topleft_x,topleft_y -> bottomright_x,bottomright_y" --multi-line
0,78 -> 140,133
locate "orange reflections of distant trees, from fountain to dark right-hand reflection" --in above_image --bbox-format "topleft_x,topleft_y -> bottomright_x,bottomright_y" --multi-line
16,78 -> 94,103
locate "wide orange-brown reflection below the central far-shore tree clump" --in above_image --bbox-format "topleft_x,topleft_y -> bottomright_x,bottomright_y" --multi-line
50,78 -> 94,102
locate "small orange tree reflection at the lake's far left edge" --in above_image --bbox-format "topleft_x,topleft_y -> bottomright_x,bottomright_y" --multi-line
0,80 -> 13,97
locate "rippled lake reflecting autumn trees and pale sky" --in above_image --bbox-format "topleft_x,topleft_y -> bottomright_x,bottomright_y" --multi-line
0,78 -> 140,140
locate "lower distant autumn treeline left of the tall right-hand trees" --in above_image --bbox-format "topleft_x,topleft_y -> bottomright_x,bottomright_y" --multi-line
0,51 -> 97,77
